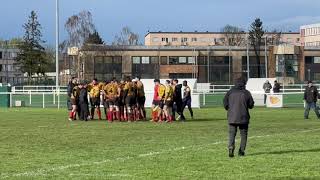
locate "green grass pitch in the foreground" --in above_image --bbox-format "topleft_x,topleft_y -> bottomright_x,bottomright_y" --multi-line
0,108 -> 320,180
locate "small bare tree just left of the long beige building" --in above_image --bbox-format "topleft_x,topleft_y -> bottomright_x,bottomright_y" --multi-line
112,26 -> 140,45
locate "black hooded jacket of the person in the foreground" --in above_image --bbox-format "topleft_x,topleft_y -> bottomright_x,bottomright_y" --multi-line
223,81 -> 254,124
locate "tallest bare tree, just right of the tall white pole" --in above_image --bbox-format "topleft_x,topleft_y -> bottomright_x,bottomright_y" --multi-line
64,11 -> 95,47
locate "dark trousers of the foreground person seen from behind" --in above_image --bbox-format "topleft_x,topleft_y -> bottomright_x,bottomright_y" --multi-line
228,124 -> 249,152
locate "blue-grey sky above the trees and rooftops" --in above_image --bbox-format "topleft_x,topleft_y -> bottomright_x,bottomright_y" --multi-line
0,0 -> 320,45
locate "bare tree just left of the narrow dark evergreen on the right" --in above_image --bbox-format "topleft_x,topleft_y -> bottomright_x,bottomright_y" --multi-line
221,24 -> 245,46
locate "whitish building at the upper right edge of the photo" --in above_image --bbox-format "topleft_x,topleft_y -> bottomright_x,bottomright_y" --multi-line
300,23 -> 320,47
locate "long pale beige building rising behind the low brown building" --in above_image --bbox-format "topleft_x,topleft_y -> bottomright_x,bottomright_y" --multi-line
144,31 -> 301,46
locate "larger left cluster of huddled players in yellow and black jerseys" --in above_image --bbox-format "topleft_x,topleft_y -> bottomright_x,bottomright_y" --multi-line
68,77 -> 146,122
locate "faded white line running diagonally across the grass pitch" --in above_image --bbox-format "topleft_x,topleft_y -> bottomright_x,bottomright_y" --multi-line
0,128 -> 320,179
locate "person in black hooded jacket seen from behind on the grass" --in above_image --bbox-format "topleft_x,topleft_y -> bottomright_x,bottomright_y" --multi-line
223,79 -> 254,157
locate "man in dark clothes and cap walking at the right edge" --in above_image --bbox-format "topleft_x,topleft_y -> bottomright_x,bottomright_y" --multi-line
304,81 -> 320,119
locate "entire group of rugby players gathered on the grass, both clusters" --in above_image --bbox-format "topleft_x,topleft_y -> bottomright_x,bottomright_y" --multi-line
67,77 -> 193,122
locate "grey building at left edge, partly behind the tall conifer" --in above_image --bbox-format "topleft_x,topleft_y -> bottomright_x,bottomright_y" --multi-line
0,44 -> 24,84
